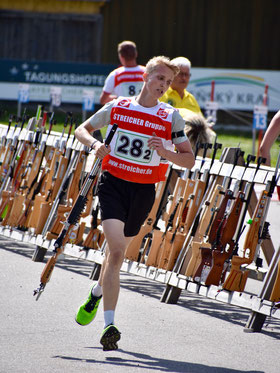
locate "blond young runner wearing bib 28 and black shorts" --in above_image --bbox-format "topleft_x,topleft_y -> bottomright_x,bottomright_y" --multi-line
75,56 -> 194,350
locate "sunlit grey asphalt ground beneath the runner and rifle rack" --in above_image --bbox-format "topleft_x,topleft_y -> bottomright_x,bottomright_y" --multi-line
0,236 -> 280,373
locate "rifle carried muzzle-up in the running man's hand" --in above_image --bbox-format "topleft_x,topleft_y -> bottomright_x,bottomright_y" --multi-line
33,124 -> 117,300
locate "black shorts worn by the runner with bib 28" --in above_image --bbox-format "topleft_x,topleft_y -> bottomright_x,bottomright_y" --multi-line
98,171 -> 155,237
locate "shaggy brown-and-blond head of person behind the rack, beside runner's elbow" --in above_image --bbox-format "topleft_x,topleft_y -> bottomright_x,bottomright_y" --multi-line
179,109 -> 216,157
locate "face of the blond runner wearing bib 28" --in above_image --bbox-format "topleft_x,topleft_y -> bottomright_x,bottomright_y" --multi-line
144,65 -> 174,99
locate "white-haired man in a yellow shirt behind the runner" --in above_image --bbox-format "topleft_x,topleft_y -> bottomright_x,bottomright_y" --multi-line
160,57 -> 202,114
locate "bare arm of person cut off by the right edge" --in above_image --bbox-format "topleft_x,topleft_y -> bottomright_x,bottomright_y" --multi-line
259,110 -> 280,201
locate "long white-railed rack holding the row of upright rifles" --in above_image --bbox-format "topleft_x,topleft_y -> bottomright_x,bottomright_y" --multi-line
0,121 -> 280,331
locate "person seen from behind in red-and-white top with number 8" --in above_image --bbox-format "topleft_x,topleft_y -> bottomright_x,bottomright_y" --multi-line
100,40 -> 145,105
